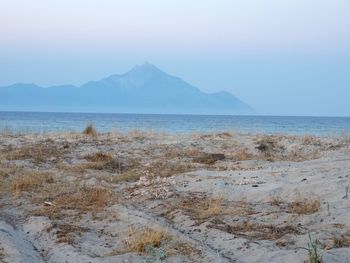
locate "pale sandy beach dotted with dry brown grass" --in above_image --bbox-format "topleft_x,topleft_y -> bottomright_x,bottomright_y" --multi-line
0,131 -> 350,263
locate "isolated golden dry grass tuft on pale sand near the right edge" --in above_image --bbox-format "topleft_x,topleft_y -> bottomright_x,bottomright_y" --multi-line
288,196 -> 321,215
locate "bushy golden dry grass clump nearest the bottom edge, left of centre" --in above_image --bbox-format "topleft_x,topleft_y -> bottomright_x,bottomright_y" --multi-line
116,227 -> 172,254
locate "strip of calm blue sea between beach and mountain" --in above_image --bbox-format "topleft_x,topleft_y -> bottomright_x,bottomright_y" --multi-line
0,112 -> 350,135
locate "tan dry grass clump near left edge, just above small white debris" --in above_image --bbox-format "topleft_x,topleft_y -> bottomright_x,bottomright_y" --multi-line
10,172 -> 54,194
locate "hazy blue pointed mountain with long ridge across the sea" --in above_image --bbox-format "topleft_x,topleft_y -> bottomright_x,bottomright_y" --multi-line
0,63 -> 254,114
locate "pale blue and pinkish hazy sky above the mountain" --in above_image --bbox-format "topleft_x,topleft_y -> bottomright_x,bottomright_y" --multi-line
0,0 -> 350,116
